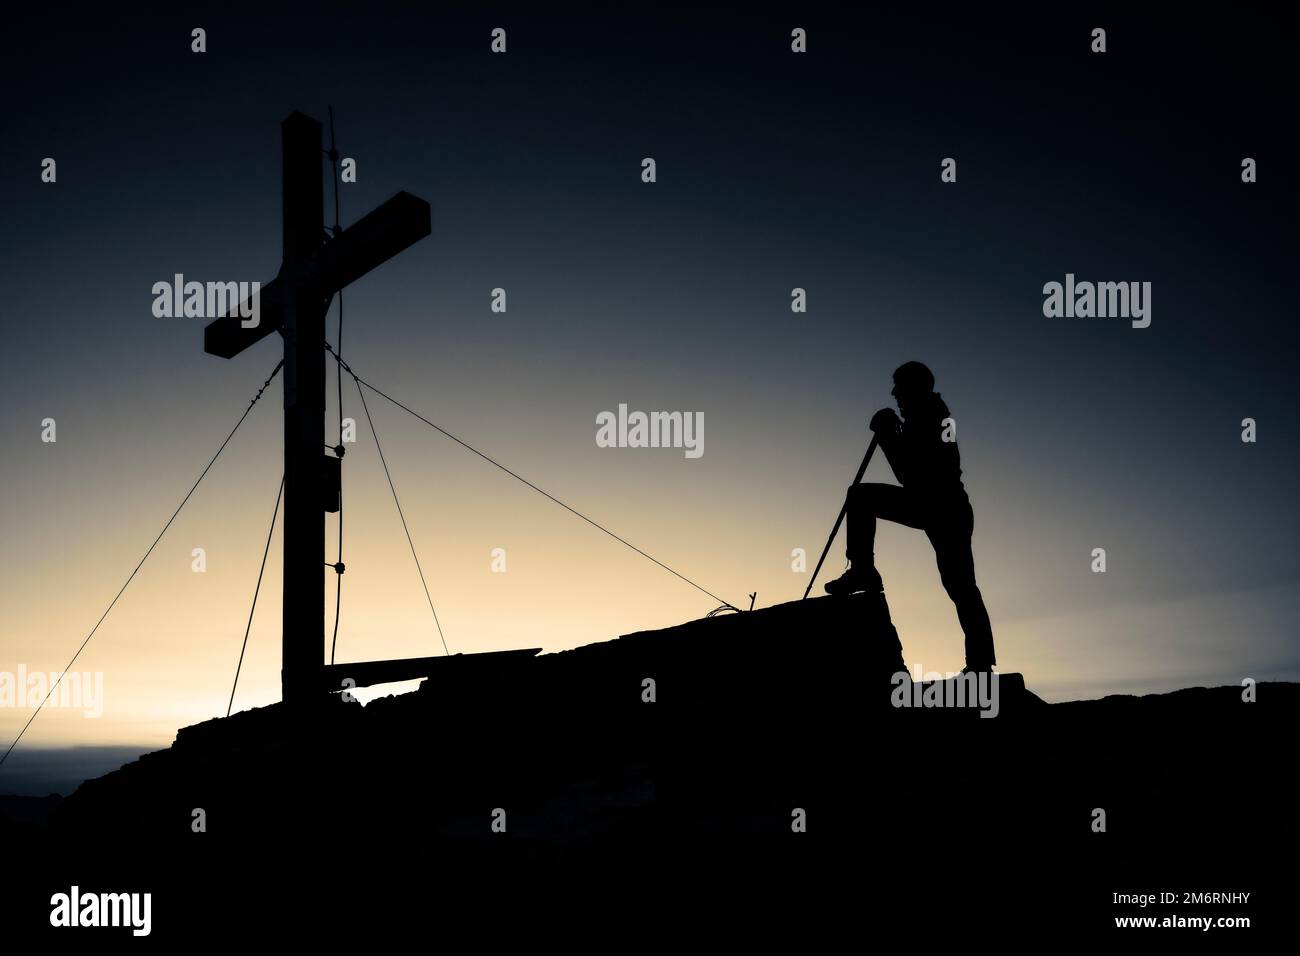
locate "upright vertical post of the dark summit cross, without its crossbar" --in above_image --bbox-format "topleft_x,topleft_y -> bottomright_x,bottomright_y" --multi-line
280,113 -> 326,705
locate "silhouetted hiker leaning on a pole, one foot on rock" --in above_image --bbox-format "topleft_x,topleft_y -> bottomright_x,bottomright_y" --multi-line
826,362 -> 996,671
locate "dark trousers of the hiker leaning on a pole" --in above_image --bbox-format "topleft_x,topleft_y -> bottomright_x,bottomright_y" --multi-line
846,483 -> 997,669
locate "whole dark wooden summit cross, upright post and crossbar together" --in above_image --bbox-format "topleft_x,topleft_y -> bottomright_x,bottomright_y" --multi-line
203,112 -> 430,704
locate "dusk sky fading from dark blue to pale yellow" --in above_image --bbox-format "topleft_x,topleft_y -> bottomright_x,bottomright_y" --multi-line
0,3 -> 1300,770
